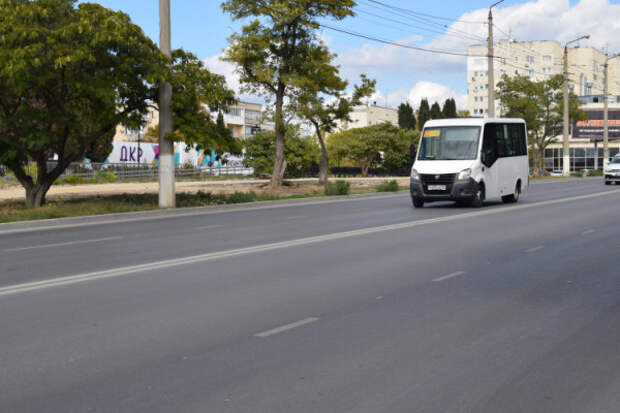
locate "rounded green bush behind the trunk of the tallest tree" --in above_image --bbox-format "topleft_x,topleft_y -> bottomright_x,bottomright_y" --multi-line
243,125 -> 319,177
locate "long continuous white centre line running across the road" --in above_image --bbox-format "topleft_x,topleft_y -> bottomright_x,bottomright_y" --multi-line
0,189 -> 620,296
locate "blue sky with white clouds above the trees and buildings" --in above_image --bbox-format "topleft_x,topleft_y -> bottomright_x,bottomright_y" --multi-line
85,0 -> 620,109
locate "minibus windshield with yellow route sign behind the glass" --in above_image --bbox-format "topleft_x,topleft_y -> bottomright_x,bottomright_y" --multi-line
418,126 -> 480,161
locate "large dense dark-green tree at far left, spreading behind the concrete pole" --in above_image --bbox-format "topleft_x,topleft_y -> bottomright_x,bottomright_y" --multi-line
0,0 -> 236,207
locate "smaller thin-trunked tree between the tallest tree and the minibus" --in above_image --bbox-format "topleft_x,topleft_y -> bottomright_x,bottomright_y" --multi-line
293,73 -> 376,183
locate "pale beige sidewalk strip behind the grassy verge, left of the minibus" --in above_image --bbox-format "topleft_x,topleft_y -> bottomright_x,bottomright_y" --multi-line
0,177 -> 409,202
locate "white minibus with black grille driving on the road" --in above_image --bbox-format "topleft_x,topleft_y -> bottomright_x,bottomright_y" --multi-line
411,118 -> 529,208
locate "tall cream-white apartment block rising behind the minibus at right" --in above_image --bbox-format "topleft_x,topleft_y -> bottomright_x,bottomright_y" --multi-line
467,40 -> 620,116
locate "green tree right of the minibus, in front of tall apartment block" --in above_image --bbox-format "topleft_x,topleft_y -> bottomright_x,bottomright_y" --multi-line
497,75 -> 586,168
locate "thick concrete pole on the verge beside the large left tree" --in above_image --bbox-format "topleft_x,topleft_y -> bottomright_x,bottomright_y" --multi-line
159,0 -> 176,208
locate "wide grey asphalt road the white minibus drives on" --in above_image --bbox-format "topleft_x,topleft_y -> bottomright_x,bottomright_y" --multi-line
0,179 -> 620,413
